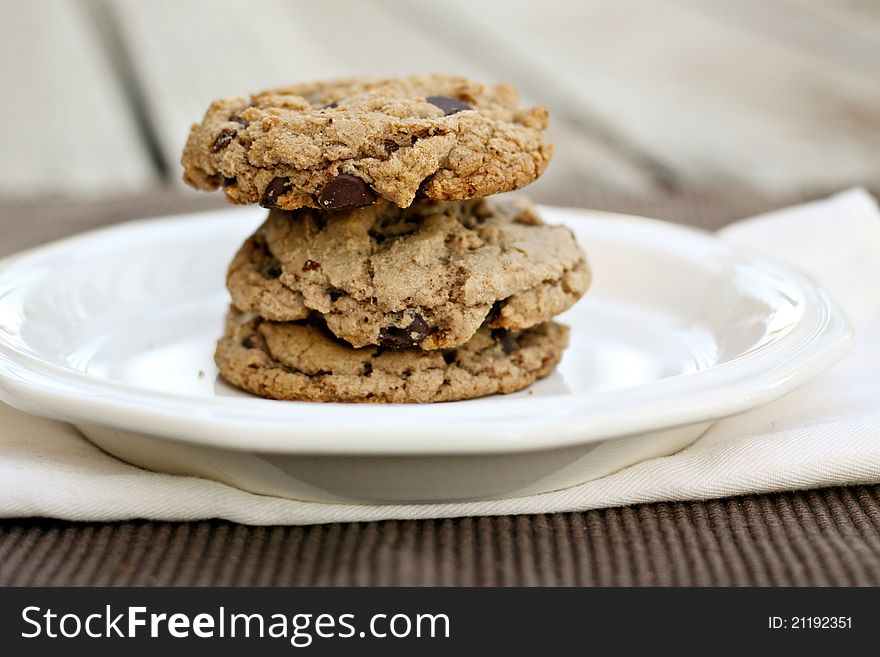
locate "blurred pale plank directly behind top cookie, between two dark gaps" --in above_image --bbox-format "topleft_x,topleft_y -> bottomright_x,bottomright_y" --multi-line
109,0 -> 655,193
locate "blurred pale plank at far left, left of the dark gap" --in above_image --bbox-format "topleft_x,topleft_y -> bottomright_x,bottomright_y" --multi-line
0,0 -> 156,197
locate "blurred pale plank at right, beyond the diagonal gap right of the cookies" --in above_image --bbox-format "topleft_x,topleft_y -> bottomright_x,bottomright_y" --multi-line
432,0 -> 880,195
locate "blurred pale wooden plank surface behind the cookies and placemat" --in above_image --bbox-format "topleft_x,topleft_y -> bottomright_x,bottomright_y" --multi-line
0,0 -> 880,204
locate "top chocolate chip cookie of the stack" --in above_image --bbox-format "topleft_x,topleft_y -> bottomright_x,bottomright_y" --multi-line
182,75 -> 552,210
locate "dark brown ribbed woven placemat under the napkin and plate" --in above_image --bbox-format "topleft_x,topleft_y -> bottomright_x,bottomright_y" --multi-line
0,183 -> 880,586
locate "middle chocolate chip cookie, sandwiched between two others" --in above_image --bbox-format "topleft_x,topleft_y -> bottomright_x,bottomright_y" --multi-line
227,197 -> 590,350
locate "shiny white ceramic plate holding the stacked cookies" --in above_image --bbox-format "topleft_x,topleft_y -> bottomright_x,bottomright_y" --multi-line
0,207 -> 851,501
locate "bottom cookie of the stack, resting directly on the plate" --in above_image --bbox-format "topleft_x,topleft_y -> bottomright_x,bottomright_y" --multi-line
214,308 -> 568,403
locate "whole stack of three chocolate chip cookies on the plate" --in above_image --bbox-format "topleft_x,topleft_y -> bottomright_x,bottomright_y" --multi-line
183,75 -> 590,402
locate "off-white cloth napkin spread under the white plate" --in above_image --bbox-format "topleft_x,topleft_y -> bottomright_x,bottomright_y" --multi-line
0,190 -> 880,524
